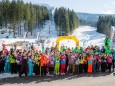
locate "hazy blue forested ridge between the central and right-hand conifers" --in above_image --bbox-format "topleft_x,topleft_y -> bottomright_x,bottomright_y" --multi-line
76,12 -> 115,26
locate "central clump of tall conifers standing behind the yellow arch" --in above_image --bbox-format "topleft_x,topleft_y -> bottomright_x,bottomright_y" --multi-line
54,7 -> 79,35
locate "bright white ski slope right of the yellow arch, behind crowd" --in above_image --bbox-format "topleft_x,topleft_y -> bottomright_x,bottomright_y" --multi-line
72,26 -> 105,46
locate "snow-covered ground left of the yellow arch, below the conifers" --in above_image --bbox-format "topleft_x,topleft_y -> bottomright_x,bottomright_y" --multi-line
0,21 -> 58,49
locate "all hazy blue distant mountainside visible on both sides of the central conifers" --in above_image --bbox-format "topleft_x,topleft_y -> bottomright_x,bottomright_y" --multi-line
36,4 -> 115,27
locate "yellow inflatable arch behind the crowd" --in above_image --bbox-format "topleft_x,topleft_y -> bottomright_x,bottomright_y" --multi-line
56,36 -> 80,49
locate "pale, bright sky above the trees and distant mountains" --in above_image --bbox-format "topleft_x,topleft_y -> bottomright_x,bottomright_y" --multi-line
9,0 -> 115,14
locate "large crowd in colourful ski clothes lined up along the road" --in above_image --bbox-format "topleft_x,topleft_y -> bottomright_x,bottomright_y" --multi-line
0,36 -> 115,77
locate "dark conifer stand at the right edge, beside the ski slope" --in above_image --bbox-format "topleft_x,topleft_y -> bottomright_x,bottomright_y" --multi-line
97,16 -> 115,37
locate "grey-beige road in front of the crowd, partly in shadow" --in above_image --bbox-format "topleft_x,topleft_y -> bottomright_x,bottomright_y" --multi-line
0,74 -> 115,86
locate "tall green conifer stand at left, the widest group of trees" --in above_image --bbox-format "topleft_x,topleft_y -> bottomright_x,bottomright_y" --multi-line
0,0 -> 49,36
